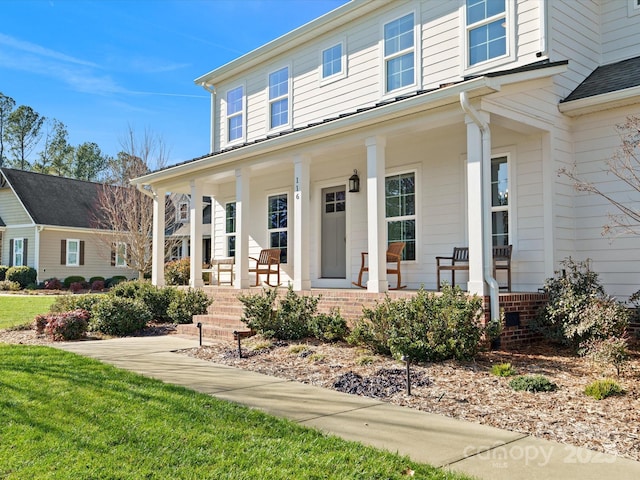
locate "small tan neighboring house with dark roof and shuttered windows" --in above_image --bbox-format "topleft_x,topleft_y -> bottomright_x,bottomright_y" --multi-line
0,168 -> 137,281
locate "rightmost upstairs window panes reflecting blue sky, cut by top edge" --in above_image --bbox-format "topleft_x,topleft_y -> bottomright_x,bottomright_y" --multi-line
466,0 -> 507,66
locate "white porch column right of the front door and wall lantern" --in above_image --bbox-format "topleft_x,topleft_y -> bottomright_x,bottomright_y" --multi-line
365,136 -> 389,293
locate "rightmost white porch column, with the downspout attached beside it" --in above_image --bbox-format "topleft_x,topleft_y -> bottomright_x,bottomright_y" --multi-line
465,116 -> 490,295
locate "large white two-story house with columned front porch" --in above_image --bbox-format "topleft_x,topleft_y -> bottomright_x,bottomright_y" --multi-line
134,0 -> 640,316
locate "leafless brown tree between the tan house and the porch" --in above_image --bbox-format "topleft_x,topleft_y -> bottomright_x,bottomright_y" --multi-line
94,128 -> 182,279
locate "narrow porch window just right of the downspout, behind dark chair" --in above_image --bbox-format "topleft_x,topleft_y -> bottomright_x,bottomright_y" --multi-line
491,157 -> 509,245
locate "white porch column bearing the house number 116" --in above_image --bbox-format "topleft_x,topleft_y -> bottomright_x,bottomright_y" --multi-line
289,155 -> 311,291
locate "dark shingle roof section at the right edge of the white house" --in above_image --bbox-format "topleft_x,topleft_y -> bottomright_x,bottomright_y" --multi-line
560,57 -> 640,103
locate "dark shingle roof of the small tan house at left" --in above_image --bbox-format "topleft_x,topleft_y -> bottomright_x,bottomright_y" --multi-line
0,168 -> 109,228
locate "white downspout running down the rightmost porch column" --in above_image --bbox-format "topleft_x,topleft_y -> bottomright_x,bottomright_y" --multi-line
460,92 -> 500,319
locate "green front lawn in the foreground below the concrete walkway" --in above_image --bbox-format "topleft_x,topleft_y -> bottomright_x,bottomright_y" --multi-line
0,345 -> 468,480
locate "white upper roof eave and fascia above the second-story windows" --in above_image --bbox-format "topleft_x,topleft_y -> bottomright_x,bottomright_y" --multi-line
194,0 -> 393,86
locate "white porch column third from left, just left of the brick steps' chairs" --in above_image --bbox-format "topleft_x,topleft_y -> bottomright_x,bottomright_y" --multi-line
233,168 -> 251,289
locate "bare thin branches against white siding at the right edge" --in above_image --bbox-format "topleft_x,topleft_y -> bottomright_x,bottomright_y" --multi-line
559,116 -> 640,235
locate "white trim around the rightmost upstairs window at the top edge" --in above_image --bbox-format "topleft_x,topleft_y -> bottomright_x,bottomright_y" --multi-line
460,0 -> 516,76
